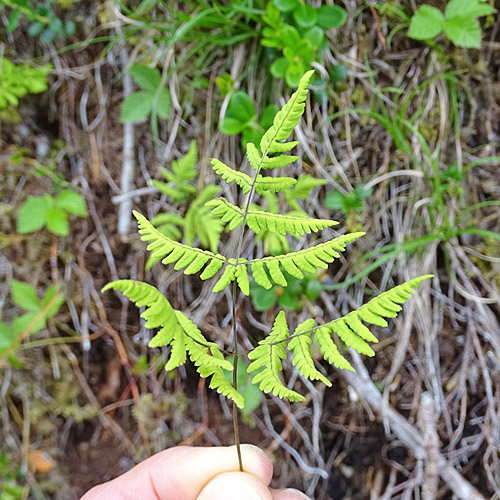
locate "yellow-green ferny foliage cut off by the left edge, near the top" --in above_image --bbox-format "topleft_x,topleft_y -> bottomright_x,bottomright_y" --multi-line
0,57 -> 52,109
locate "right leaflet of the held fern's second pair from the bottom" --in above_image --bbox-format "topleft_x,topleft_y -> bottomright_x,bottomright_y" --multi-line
248,232 -> 365,290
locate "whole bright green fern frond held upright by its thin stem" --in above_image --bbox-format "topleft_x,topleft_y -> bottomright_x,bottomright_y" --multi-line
103,71 -> 430,460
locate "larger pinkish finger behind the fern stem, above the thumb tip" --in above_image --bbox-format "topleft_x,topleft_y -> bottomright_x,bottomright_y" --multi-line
81,445 -> 273,500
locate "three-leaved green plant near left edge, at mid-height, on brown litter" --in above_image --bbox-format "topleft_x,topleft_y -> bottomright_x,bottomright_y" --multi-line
17,189 -> 87,236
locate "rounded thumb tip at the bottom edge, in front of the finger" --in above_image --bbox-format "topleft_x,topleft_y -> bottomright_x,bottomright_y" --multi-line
196,472 -> 272,500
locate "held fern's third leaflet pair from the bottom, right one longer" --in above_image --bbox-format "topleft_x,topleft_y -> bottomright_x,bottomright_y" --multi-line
205,198 -> 338,236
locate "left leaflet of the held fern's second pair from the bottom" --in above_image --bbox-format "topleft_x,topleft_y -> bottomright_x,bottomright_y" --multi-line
134,211 -> 228,280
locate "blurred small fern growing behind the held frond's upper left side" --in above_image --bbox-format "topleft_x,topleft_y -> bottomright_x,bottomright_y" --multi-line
147,141 -> 224,262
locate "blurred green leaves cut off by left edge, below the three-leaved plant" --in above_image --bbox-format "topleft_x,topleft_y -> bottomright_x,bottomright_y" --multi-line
0,280 -> 64,364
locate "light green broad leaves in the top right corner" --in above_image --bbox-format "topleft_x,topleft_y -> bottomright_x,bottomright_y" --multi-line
408,0 -> 496,49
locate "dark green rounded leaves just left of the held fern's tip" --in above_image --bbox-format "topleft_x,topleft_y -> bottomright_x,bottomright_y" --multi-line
219,90 -> 278,146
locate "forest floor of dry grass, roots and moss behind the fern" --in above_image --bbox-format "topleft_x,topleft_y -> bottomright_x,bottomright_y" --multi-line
0,0 -> 500,500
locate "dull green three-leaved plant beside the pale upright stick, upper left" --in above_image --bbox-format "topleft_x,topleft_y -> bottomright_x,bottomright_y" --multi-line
121,65 -> 170,123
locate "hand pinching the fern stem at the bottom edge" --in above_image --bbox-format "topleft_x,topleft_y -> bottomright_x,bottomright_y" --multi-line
80,444 -> 309,500
